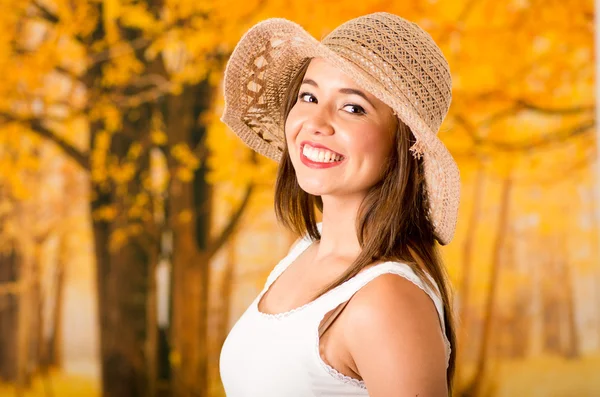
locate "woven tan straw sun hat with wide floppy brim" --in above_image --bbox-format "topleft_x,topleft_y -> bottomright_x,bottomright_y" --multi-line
221,12 -> 460,244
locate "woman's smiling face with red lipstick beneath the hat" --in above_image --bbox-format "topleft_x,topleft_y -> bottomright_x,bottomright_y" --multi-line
285,58 -> 397,200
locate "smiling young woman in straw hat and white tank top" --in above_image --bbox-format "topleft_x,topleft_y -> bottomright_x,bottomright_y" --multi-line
220,13 -> 460,397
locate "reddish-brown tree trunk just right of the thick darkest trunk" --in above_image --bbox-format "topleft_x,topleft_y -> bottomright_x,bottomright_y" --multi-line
165,82 -> 211,397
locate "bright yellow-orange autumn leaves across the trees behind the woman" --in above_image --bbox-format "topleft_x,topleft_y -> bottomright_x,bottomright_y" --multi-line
0,0 -> 599,395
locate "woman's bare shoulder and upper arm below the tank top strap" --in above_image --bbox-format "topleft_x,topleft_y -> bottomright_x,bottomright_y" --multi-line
344,274 -> 448,397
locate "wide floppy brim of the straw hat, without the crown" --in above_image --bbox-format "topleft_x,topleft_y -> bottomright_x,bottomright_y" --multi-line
221,18 -> 460,245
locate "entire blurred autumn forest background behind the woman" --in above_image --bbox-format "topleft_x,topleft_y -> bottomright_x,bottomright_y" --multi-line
0,0 -> 600,397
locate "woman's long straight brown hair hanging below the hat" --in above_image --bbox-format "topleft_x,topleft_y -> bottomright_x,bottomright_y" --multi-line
275,59 -> 456,395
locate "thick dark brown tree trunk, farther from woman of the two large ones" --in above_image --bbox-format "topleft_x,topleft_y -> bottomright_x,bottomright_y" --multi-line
81,7 -> 148,397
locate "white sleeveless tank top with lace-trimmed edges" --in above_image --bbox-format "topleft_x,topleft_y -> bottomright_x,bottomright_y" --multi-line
219,223 -> 450,397
